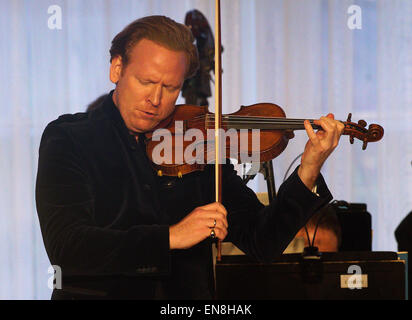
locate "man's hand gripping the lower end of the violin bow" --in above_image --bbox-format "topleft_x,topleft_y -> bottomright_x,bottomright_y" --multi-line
169,202 -> 228,249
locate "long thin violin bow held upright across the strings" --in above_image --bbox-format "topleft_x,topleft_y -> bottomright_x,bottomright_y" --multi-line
215,0 -> 222,261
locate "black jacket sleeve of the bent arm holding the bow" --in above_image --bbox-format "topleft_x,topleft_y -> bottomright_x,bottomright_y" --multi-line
36,123 -> 170,275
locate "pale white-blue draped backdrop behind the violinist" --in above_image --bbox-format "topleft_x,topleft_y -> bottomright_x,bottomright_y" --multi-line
0,0 -> 412,299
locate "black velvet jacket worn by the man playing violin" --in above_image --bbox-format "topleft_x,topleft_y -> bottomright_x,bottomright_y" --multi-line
36,94 -> 331,299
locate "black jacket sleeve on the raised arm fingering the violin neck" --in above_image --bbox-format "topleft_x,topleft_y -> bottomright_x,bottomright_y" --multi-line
222,162 -> 332,262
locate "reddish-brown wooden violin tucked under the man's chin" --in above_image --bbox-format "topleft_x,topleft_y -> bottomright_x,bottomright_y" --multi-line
146,103 -> 384,177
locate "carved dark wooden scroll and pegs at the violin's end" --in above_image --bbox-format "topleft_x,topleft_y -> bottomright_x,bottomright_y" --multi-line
342,113 -> 384,150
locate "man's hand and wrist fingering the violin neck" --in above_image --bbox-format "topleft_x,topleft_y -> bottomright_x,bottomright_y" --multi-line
298,113 -> 345,190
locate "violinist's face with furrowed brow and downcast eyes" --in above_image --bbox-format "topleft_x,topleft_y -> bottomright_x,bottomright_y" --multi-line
110,39 -> 187,133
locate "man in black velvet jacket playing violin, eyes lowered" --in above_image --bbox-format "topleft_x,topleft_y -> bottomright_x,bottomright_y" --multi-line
36,16 -> 343,299
